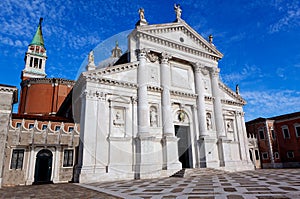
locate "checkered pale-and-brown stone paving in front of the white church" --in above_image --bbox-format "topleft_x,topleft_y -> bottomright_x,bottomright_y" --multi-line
79,169 -> 300,199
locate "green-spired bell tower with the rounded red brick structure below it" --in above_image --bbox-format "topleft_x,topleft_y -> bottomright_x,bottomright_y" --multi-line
18,18 -> 74,116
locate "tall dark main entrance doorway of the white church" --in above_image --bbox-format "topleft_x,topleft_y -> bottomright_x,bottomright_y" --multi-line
175,125 -> 193,168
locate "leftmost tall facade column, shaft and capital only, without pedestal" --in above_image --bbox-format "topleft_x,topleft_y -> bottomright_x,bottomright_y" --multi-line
137,49 -> 150,136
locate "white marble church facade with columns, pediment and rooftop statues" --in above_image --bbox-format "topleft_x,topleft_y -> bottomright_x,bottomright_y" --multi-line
73,9 -> 253,183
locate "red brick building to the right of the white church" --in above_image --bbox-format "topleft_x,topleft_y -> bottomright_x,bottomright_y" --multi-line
246,112 -> 300,168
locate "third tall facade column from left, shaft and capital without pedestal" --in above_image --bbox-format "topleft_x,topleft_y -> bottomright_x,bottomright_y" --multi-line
194,63 -> 207,137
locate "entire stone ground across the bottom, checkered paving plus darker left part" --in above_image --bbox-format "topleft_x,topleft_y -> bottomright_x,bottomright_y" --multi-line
0,169 -> 300,199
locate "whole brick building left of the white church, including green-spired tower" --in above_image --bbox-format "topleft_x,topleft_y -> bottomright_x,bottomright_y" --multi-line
0,19 -> 79,186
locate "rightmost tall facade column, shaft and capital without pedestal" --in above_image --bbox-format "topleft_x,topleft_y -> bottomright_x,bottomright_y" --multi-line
210,68 -> 226,137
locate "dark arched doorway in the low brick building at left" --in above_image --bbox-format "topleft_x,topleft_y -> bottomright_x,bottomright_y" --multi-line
34,149 -> 53,184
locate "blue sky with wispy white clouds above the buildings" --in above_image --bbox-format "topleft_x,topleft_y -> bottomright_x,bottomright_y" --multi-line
0,0 -> 300,120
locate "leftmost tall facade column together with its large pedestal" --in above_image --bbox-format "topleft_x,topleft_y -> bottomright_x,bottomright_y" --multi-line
134,49 -> 162,179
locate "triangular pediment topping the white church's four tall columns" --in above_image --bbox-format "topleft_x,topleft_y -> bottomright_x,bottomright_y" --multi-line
138,21 -> 223,59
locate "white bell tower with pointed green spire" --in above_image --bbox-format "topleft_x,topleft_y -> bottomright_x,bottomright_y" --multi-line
21,18 -> 47,80
